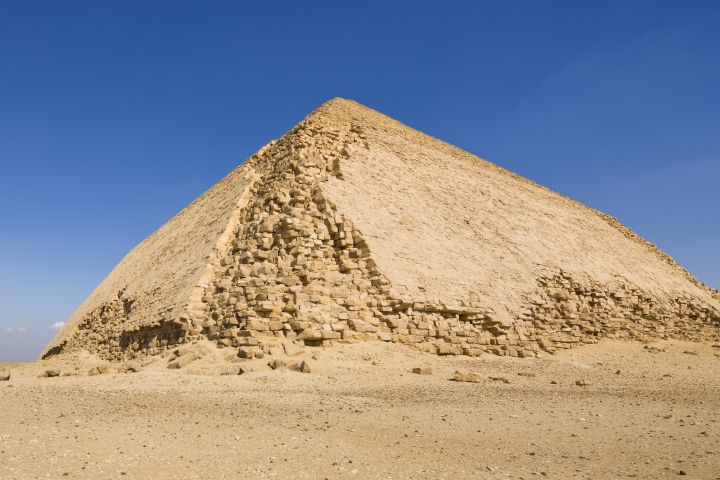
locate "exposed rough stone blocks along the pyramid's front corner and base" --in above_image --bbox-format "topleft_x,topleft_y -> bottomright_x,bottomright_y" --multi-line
43,105 -> 720,360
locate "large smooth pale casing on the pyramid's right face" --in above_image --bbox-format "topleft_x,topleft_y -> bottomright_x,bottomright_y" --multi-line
323,100 -> 713,313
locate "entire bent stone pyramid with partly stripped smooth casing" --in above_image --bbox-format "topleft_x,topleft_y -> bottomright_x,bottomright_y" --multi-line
42,99 -> 720,359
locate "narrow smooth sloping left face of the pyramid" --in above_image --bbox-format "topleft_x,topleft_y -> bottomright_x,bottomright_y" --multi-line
41,159 -> 252,356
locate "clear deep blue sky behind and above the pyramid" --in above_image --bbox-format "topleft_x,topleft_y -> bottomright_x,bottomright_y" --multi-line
0,0 -> 720,361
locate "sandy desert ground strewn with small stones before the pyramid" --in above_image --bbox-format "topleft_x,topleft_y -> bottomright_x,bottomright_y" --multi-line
0,341 -> 720,480
